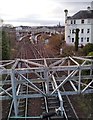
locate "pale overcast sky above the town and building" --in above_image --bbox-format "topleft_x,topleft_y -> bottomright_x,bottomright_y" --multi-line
0,0 -> 91,26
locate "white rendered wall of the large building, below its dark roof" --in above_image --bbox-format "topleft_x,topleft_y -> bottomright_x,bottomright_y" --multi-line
65,19 -> 93,45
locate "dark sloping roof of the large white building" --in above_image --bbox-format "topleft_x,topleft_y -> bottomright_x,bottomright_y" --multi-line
68,10 -> 93,19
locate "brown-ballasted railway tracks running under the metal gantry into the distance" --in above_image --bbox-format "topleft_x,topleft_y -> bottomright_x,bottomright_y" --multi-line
2,36 -> 78,120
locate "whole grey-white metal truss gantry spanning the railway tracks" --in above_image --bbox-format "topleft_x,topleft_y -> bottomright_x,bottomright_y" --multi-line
0,56 -> 93,117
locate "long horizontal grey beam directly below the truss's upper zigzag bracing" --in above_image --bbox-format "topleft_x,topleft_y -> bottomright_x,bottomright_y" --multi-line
0,65 -> 93,75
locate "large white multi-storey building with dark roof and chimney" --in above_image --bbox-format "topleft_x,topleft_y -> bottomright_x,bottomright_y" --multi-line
64,1 -> 93,45
